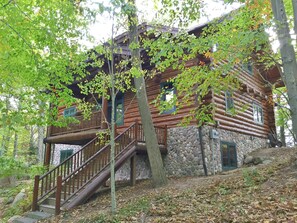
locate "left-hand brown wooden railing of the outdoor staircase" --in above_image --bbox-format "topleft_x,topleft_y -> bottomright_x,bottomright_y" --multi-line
33,132 -> 108,206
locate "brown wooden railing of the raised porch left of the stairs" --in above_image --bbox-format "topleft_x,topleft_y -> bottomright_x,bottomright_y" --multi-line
51,111 -> 101,136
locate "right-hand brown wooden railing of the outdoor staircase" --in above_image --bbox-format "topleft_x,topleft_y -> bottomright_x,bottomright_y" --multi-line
61,123 -> 138,206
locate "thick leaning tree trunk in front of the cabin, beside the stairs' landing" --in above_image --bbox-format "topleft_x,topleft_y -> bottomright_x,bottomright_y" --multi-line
128,0 -> 167,187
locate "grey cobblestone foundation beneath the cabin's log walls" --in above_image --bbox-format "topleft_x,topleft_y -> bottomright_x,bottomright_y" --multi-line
53,126 -> 267,180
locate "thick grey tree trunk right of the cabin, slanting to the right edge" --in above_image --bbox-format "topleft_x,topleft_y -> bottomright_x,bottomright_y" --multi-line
271,0 -> 297,142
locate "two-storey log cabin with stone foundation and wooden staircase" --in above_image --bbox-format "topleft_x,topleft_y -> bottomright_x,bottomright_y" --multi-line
33,21 -> 283,214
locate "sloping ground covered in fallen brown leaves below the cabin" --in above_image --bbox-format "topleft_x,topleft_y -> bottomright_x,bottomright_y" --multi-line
38,148 -> 297,223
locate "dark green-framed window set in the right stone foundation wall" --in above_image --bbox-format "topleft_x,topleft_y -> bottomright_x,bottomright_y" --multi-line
221,141 -> 237,170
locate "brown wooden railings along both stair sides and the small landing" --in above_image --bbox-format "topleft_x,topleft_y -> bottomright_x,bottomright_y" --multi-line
32,122 -> 167,213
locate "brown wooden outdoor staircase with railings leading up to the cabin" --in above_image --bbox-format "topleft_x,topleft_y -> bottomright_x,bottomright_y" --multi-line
32,122 -> 167,214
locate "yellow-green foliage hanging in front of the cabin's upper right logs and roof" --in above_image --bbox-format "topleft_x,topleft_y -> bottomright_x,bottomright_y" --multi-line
143,3 -> 270,125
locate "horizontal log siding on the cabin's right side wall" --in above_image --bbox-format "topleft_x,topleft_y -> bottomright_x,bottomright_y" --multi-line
213,62 -> 275,138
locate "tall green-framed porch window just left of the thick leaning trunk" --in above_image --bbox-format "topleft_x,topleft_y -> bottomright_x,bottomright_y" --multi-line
107,93 -> 124,126
